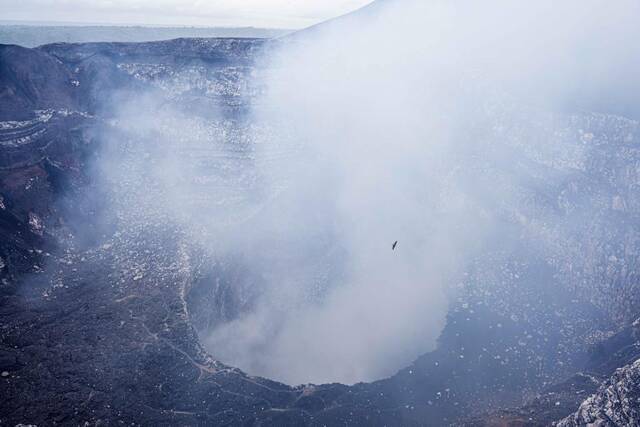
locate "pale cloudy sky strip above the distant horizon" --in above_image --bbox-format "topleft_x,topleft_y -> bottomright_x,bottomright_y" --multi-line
0,0 -> 371,28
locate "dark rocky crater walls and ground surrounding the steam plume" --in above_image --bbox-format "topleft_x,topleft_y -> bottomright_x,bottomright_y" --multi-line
0,7 -> 640,426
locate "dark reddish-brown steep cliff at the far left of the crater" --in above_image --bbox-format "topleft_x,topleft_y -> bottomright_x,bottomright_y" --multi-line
0,42 -> 97,284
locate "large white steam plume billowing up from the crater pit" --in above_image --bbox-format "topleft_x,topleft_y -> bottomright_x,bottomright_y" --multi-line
99,0 -> 640,383
